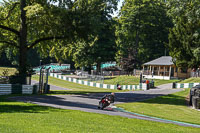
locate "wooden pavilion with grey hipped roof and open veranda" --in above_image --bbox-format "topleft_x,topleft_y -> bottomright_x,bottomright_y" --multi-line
143,56 -> 191,80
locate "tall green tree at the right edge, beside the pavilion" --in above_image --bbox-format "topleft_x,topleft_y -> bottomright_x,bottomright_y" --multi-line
168,0 -> 200,68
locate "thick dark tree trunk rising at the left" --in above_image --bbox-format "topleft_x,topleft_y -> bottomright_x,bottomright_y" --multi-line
18,0 -> 27,84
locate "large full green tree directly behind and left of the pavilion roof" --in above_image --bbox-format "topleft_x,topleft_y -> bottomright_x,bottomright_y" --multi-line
116,0 -> 171,69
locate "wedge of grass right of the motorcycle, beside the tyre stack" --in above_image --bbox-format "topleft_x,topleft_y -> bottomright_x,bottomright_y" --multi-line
117,89 -> 200,125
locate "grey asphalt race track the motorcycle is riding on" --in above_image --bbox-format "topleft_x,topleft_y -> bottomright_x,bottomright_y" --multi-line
11,82 -> 200,128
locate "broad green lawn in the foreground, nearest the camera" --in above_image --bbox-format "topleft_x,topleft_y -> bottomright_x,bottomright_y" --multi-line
0,96 -> 200,133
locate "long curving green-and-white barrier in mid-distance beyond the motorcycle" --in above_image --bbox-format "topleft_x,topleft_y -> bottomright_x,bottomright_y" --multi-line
50,73 -> 147,90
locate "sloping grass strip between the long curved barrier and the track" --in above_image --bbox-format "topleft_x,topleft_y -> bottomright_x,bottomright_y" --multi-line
32,75 -> 119,94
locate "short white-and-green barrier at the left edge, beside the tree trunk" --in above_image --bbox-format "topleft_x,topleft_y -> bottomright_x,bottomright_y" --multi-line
0,84 -> 38,95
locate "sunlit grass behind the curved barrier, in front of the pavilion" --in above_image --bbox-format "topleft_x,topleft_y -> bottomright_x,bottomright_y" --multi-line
104,76 -> 179,86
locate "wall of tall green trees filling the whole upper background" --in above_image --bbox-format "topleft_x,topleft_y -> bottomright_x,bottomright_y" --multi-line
0,0 -> 200,81
